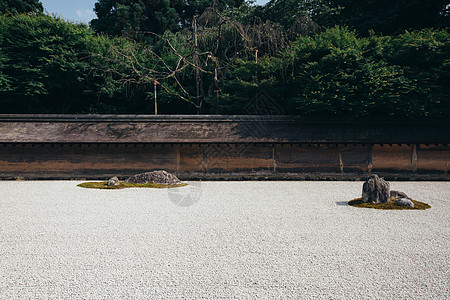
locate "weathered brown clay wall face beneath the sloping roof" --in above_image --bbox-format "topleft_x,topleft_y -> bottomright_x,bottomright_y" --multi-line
0,144 -> 450,180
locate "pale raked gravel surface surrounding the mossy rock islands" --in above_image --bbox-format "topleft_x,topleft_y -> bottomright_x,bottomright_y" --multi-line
0,181 -> 450,299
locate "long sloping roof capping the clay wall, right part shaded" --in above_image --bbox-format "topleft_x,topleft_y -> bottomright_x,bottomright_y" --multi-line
0,115 -> 450,143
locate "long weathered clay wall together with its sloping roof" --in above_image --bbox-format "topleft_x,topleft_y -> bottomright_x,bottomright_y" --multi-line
0,115 -> 450,180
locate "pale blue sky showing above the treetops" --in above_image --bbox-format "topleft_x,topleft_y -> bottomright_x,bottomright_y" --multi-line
41,0 -> 269,23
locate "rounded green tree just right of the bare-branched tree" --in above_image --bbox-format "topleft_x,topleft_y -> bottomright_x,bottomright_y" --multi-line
292,27 -> 409,119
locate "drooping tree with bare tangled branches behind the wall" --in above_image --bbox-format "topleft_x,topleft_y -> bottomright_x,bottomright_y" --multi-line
91,5 -> 319,113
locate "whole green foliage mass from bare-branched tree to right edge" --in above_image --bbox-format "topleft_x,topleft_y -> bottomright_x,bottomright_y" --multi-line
291,27 -> 450,119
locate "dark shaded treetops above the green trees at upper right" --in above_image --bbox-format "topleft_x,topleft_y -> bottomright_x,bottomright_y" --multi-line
254,0 -> 450,35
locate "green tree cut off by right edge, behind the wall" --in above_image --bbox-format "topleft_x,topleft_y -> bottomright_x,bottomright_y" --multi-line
383,29 -> 450,117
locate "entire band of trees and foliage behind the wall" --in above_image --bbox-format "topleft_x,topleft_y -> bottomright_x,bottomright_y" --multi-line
0,0 -> 450,120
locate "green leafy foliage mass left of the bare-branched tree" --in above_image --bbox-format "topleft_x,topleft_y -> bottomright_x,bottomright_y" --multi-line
0,15 -> 158,113
